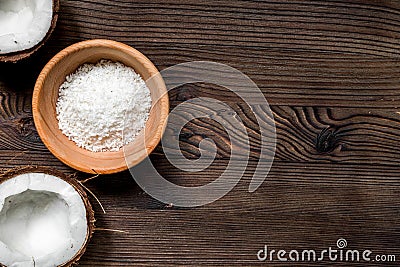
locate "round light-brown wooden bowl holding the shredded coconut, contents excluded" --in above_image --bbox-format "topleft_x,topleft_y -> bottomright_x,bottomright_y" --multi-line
32,40 -> 169,174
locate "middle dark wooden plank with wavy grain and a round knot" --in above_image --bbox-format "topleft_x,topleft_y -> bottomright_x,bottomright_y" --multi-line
0,87 -> 400,165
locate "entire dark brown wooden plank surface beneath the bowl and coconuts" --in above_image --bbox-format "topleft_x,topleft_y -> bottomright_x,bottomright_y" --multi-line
0,0 -> 400,266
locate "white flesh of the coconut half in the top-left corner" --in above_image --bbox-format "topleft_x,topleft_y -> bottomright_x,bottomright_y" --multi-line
0,0 -> 53,55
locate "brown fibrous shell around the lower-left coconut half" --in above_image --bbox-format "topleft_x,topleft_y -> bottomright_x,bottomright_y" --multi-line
0,166 -> 96,267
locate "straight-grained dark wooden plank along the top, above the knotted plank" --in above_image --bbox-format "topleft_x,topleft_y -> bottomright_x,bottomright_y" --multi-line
0,0 -> 400,108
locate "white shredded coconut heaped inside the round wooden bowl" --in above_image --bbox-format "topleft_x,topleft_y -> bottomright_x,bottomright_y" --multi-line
56,60 -> 151,152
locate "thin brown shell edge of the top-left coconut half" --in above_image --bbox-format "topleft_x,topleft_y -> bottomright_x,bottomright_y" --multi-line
0,0 -> 60,62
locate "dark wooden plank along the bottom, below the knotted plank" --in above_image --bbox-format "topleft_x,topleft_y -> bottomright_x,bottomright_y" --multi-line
72,157 -> 400,266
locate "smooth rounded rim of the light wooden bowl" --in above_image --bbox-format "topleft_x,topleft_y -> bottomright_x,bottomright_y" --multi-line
32,39 -> 170,174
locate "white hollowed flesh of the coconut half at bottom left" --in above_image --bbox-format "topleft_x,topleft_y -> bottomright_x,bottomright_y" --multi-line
0,173 -> 89,267
